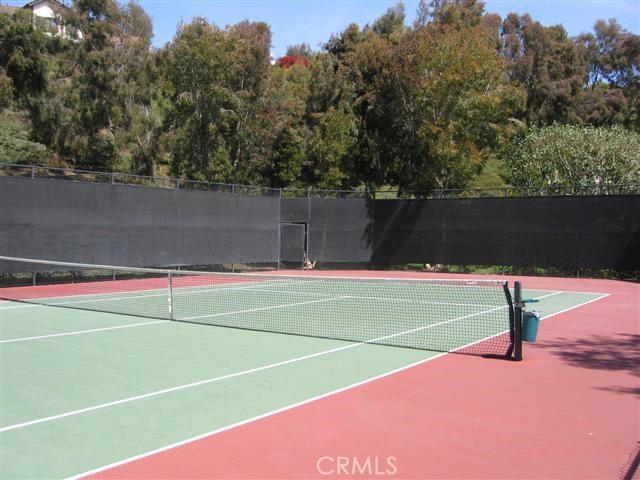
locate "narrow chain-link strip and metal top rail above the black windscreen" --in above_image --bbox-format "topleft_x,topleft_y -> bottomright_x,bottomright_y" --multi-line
0,163 -> 640,199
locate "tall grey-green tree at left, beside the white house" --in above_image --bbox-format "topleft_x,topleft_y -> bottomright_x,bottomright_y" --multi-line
28,0 -> 160,174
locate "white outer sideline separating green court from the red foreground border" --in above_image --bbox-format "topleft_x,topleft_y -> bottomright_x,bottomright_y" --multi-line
66,290 -> 610,480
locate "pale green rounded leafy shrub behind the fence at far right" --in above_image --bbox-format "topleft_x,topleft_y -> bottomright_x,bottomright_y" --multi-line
505,125 -> 640,187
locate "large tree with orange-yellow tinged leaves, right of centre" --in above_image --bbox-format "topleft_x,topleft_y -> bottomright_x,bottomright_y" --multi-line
395,26 -> 525,190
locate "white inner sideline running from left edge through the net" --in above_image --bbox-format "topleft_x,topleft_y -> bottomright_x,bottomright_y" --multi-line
0,305 -> 507,433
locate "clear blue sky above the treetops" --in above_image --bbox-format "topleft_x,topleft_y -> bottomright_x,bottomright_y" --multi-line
6,0 -> 640,58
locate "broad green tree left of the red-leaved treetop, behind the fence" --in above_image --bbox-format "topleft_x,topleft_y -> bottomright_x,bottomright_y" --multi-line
164,18 -> 271,183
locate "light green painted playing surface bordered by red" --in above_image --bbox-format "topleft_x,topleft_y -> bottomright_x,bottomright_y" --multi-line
0,284 -> 602,479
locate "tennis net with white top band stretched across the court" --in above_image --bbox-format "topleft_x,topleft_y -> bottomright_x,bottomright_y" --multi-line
0,256 -> 520,358
